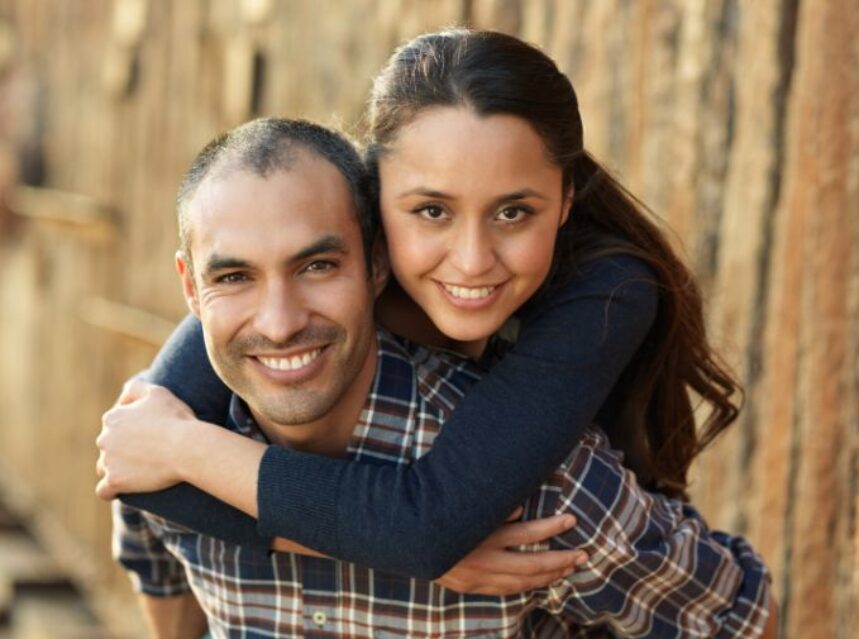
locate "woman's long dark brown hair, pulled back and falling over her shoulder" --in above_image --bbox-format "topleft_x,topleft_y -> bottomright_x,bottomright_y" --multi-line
367,29 -> 739,498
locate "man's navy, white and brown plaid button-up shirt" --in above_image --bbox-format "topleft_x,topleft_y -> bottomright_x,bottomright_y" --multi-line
114,331 -> 769,639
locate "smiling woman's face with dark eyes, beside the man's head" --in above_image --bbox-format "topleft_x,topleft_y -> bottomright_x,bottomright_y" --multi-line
379,107 -> 571,350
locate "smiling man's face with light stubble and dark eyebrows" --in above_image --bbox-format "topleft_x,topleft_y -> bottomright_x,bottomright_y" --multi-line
177,152 -> 377,438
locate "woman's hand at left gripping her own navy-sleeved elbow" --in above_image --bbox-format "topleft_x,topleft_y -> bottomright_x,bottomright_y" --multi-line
95,380 -> 197,500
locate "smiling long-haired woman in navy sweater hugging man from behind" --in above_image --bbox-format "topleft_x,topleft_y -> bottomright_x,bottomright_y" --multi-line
97,31 -> 776,632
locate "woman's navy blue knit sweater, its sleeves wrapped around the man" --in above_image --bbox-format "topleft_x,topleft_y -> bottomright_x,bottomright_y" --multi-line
121,256 -> 658,579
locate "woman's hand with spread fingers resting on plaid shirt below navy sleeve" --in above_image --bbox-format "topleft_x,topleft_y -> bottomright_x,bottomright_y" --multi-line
435,508 -> 587,595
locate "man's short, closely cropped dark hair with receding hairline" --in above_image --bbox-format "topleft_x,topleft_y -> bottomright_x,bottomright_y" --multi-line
176,118 -> 378,265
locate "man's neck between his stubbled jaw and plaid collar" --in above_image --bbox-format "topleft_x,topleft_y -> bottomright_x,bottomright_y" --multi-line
249,331 -> 379,457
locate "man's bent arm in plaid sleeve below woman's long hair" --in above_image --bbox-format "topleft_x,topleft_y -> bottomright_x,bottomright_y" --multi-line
532,431 -> 772,639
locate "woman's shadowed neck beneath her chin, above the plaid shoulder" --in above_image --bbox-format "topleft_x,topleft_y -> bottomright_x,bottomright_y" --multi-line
375,278 -> 489,359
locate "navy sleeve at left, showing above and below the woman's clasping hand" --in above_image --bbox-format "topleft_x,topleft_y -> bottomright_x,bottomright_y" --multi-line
119,315 -> 269,548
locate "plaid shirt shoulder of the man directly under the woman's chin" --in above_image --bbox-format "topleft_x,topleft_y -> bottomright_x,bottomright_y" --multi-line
379,329 -> 482,419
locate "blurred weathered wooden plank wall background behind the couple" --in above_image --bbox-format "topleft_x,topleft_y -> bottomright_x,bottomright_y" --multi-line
0,0 -> 859,639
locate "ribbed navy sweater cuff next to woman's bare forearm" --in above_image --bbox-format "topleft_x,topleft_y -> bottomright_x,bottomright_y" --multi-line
257,446 -> 340,556
